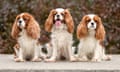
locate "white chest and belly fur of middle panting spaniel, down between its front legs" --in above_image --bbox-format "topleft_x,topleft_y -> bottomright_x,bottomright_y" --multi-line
51,24 -> 72,59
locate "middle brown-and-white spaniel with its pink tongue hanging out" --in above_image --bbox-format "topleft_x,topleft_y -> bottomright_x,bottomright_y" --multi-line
45,8 -> 75,62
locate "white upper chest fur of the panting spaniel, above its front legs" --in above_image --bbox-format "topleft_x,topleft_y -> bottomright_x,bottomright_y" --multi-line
51,24 -> 72,46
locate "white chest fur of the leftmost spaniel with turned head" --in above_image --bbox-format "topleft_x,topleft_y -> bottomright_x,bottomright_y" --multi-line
18,30 -> 37,55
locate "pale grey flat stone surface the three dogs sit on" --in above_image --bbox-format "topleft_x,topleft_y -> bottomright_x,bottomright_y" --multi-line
0,54 -> 120,72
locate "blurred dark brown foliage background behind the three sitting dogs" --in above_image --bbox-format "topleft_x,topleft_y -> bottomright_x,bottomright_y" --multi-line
0,0 -> 120,54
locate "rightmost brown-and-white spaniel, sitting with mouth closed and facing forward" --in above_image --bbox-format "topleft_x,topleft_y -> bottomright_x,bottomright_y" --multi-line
77,14 -> 110,62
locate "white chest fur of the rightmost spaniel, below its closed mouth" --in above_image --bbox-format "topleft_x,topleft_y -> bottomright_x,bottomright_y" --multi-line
80,31 -> 98,54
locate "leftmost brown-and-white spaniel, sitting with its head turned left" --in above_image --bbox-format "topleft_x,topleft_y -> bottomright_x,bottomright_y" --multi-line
11,13 -> 41,62
